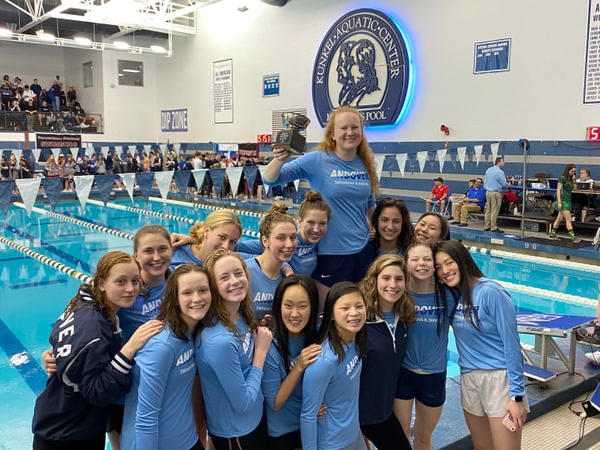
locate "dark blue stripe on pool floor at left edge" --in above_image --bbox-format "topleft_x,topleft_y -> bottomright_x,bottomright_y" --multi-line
0,319 -> 48,396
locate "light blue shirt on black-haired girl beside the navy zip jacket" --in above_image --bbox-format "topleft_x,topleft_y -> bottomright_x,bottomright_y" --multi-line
300,340 -> 362,450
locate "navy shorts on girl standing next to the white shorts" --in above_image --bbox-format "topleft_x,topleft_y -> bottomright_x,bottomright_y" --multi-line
396,367 -> 446,408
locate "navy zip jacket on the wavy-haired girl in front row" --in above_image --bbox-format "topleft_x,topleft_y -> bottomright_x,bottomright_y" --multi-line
359,316 -> 408,425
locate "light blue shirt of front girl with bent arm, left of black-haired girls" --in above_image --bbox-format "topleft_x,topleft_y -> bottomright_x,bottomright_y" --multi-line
195,318 -> 264,438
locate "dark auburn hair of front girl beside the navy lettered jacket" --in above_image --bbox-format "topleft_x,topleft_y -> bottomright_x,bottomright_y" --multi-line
158,264 -> 215,341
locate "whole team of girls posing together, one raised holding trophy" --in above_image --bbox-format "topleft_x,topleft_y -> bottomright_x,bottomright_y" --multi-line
32,108 -> 528,450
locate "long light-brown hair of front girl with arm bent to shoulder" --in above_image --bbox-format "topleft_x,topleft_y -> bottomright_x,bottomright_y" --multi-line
204,248 -> 257,335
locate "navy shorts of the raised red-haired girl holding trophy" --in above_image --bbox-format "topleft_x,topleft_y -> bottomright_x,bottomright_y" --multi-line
312,244 -> 376,287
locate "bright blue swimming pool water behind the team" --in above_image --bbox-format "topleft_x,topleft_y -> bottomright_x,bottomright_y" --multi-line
0,200 -> 600,450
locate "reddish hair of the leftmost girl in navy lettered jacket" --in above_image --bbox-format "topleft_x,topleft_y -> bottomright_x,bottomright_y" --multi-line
65,251 -> 140,327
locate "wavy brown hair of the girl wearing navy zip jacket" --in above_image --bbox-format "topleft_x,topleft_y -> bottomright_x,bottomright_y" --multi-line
359,254 -> 415,324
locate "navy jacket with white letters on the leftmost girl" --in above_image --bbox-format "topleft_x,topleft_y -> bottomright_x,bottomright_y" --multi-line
32,289 -> 133,441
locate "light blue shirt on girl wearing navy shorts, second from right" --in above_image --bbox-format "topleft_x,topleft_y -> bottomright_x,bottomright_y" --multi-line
402,292 -> 453,373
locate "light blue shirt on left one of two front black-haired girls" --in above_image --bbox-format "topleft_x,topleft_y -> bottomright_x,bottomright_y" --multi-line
262,336 -> 304,437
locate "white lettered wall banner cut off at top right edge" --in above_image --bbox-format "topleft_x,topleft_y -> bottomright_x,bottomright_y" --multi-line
583,0 -> 600,103
